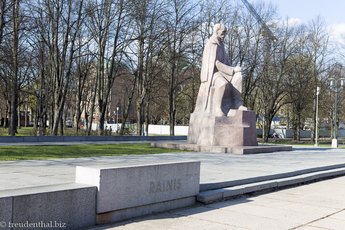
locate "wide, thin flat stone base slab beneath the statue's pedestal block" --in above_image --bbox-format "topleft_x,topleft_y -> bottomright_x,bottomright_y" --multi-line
151,141 -> 292,154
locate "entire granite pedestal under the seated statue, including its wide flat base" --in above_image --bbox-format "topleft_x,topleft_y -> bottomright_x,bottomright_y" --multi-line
151,110 -> 292,154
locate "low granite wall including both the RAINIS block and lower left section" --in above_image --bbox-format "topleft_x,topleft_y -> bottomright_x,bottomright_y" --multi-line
0,161 -> 200,229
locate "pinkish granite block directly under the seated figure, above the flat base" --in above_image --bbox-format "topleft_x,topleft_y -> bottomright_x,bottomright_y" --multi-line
187,110 -> 258,146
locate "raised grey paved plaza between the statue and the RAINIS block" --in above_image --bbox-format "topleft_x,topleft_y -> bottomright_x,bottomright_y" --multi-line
0,145 -> 345,190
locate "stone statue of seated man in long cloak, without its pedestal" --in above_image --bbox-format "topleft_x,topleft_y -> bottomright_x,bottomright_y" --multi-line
194,24 -> 247,116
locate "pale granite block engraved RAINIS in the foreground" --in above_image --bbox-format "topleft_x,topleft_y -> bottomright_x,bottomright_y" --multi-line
76,161 -> 200,214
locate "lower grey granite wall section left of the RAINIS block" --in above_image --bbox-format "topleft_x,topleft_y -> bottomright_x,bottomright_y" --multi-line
0,183 -> 96,229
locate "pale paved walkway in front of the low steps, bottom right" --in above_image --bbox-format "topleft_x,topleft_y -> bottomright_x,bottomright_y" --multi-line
91,177 -> 345,230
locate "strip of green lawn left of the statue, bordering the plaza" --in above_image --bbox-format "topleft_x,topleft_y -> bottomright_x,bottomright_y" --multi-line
0,143 -> 181,161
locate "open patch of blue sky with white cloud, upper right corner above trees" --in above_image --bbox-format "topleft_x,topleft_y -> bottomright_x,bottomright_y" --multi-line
248,0 -> 345,44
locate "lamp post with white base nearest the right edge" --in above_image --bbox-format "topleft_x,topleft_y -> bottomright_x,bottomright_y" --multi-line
329,78 -> 345,148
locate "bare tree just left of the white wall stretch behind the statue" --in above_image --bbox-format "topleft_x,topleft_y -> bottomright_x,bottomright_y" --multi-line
130,0 -> 166,135
